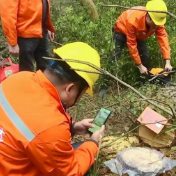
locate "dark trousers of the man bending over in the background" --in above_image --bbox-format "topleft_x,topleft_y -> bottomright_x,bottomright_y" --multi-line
114,32 -> 150,69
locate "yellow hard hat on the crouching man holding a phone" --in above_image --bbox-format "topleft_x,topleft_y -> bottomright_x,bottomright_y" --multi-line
53,42 -> 100,96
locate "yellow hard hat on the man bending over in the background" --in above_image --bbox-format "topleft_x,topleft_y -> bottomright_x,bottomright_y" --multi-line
146,0 -> 167,26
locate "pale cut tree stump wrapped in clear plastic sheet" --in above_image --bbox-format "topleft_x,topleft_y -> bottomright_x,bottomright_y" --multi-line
105,147 -> 176,176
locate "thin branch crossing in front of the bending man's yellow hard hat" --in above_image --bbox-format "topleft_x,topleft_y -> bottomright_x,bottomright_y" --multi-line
100,4 -> 176,19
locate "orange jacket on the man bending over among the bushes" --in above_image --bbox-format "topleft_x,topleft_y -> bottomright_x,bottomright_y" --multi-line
114,6 -> 170,65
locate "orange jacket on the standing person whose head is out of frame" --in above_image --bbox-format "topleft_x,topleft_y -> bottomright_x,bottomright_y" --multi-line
0,0 -> 55,46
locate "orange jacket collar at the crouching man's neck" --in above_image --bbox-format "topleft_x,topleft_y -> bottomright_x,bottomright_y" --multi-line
36,70 -> 66,114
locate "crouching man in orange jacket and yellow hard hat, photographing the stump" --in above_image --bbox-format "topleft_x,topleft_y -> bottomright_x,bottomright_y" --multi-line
0,42 -> 105,176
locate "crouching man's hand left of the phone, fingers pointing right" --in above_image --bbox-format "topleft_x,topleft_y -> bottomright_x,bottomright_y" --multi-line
73,119 -> 94,135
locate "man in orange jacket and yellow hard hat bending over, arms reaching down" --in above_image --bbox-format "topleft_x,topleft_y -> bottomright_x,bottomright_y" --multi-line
100,0 -> 172,97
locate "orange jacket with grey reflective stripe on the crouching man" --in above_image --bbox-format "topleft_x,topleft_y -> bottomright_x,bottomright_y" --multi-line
0,71 -> 98,176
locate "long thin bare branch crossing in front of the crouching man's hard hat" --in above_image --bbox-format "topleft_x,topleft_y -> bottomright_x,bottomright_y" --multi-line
43,57 -> 173,116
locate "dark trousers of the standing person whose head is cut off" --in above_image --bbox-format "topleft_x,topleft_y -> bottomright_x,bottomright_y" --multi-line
18,30 -> 50,71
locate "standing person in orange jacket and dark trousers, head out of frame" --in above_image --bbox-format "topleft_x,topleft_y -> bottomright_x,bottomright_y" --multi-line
0,0 -> 55,71
